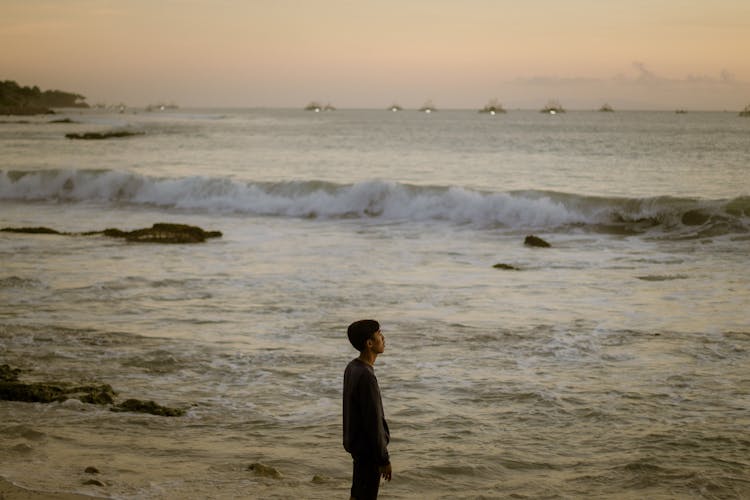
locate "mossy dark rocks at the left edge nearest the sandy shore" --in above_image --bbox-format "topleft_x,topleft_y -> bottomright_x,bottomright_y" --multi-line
0,365 -> 185,417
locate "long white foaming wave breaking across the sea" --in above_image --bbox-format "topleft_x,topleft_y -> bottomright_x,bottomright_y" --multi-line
0,169 -> 750,237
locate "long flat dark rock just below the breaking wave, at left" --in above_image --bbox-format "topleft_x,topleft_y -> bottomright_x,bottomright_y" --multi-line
0,222 -> 222,243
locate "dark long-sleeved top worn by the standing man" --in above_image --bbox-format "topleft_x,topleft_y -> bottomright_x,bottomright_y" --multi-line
344,358 -> 391,465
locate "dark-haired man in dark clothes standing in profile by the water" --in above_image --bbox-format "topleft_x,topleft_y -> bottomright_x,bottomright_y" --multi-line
344,319 -> 391,500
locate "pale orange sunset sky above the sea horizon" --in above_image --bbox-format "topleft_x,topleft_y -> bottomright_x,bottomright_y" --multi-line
0,0 -> 750,110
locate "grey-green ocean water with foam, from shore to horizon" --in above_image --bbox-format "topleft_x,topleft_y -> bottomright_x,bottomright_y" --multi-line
0,109 -> 750,499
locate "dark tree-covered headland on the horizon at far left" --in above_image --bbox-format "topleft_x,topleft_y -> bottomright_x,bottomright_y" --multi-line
0,80 -> 89,115
